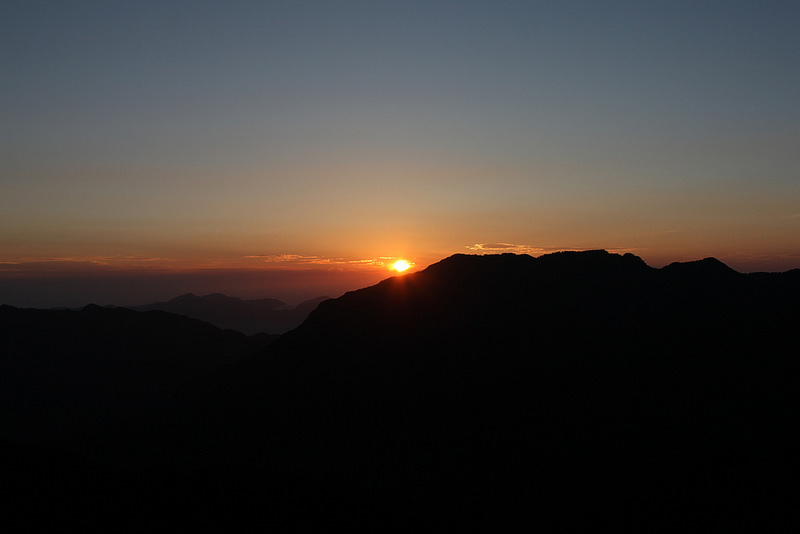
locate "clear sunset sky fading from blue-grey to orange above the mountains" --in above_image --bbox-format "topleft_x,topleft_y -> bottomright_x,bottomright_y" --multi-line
0,0 -> 800,306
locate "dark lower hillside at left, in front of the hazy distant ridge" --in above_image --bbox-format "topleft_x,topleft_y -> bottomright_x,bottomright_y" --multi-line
0,305 -> 266,445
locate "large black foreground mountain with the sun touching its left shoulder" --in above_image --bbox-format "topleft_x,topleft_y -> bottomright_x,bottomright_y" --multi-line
0,251 -> 800,529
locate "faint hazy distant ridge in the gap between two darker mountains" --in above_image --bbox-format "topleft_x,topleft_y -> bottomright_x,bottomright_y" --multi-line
130,293 -> 330,335
